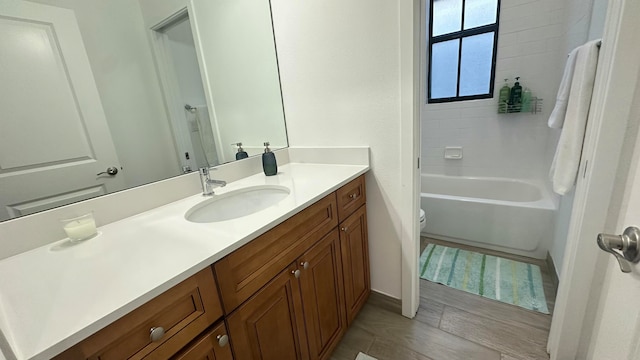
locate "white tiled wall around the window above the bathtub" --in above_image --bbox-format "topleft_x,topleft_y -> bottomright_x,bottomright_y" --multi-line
422,0 -> 564,179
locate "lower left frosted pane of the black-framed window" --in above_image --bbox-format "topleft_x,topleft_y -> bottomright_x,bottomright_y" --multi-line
430,39 -> 460,99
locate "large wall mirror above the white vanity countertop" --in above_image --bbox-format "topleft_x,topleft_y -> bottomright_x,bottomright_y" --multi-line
0,0 -> 287,220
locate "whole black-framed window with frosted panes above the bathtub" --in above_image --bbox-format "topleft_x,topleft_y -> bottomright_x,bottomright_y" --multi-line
427,0 -> 500,103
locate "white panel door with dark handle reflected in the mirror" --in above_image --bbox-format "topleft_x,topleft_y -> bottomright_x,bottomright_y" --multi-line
0,0 -> 124,220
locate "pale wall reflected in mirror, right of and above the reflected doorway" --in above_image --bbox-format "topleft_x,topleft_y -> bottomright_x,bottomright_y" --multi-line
139,0 -> 287,161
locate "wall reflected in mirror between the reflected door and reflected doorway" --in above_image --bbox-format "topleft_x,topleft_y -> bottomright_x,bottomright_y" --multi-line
28,0 -> 180,187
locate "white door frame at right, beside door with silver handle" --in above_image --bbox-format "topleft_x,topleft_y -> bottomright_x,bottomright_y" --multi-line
547,0 -> 640,359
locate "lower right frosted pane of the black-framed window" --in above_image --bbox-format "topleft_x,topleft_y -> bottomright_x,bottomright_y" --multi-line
460,32 -> 494,96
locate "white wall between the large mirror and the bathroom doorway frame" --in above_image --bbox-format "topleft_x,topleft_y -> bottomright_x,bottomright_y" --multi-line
272,0 -> 404,298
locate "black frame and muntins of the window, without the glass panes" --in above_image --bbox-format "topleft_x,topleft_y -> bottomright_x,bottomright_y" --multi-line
427,0 -> 500,104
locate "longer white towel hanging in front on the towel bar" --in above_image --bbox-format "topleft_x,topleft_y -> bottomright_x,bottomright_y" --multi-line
549,40 -> 600,195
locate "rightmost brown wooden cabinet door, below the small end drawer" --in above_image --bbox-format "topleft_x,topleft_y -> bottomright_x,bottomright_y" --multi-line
340,205 -> 371,324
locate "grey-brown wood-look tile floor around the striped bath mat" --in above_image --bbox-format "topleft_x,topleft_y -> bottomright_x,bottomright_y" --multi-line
331,238 -> 555,360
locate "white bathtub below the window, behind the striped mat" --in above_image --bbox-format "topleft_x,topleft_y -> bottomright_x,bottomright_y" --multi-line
420,174 -> 556,259
